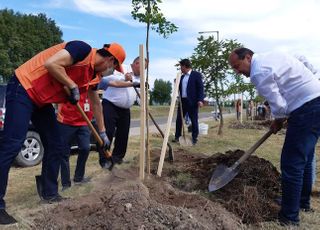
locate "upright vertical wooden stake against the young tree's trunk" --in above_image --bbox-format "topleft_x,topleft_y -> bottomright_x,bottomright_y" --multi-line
139,44 -> 146,180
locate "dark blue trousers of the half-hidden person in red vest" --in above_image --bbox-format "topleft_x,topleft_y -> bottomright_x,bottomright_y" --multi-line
59,122 -> 90,187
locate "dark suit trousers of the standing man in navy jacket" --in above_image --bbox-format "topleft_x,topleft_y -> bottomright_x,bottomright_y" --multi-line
175,98 -> 199,142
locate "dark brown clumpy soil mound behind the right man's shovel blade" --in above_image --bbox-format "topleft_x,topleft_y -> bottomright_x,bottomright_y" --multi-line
156,150 -> 281,224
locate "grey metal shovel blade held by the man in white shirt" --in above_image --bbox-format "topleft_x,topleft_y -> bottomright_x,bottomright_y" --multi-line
208,165 -> 239,192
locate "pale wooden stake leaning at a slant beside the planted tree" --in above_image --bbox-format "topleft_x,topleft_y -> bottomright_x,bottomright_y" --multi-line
157,73 -> 181,177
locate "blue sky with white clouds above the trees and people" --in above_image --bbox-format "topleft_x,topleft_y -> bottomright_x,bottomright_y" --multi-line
0,0 -> 320,87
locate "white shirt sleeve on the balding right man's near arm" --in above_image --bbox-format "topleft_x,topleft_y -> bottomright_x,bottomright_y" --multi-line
250,71 -> 288,118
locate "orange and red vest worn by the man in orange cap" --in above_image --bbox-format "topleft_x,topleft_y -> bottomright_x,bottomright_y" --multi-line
15,43 -> 101,107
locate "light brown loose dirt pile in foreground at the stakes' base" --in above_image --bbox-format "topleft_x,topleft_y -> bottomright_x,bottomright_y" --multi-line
32,169 -> 240,229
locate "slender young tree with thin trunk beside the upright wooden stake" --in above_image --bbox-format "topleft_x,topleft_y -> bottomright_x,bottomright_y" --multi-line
131,0 -> 178,173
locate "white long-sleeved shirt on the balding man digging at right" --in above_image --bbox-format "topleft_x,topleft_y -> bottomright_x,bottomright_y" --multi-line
250,52 -> 320,118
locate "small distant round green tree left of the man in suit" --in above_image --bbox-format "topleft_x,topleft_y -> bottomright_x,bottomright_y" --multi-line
151,79 -> 172,105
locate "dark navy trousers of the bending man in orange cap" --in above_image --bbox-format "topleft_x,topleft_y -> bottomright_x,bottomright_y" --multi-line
0,76 -> 62,209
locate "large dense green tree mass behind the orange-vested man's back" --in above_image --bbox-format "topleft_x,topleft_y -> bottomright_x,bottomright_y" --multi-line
0,9 -> 63,81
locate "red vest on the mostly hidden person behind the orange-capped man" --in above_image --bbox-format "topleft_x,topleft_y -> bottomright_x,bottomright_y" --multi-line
57,88 -> 93,126
